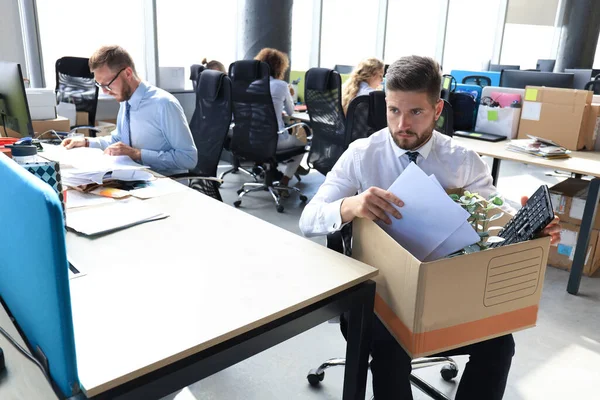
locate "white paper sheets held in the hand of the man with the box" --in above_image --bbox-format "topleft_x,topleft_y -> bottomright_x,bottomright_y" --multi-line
380,163 -> 480,261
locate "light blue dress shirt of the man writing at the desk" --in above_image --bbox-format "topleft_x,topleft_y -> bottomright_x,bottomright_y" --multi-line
90,82 -> 198,175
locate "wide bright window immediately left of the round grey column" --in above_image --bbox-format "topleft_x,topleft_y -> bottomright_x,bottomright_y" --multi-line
156,0 -> 238,89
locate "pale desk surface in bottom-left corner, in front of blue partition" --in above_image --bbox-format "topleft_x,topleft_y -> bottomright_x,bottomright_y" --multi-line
0,305 -> 58,400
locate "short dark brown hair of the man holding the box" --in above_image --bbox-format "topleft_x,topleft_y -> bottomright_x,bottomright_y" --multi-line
385,56 -> 442,105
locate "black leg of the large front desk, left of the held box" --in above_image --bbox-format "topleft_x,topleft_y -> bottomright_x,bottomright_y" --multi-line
342,282 -> 375,400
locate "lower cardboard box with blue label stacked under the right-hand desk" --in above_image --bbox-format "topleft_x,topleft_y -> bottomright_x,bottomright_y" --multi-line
548,223 -> 600,276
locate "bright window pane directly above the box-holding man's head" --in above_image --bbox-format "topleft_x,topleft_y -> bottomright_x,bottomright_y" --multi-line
384,0 -> 445,64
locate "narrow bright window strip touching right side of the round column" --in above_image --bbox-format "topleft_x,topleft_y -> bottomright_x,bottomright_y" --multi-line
290,0 -> 316,71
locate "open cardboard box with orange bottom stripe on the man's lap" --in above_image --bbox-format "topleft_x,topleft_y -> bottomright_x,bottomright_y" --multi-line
352,216 -> 550,358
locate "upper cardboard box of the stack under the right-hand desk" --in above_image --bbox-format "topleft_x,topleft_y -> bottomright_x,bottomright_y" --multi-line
548,178 -> 600,229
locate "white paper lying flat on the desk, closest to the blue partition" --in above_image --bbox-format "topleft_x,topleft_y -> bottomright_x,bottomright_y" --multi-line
67,201 -> 169,235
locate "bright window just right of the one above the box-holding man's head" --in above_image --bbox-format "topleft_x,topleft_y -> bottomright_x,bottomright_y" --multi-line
442,0 -> 504,73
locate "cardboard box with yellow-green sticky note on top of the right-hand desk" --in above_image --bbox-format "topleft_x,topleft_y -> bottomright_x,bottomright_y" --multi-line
518,86 -> 593,150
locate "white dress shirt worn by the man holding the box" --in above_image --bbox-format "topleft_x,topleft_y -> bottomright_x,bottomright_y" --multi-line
300,128 -> 496,236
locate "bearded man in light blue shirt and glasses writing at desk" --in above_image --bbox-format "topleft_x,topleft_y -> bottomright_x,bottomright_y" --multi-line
63,46 -> 198,175
